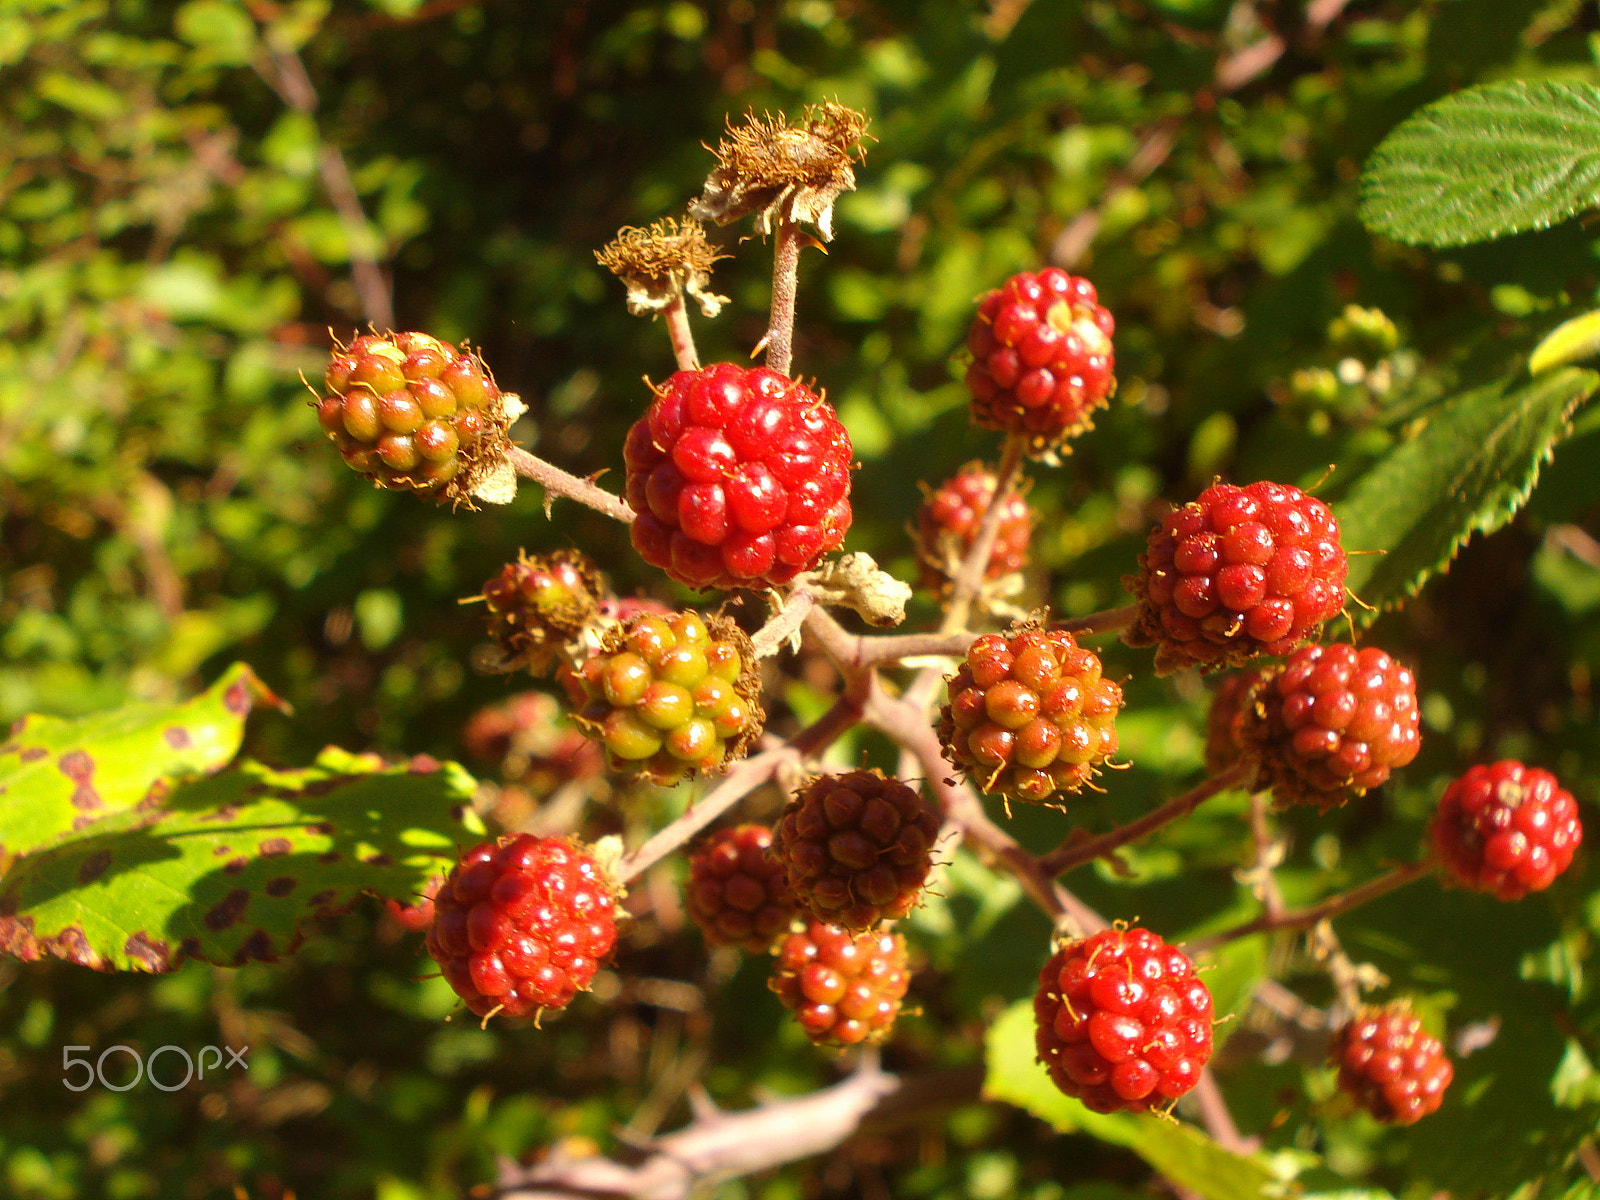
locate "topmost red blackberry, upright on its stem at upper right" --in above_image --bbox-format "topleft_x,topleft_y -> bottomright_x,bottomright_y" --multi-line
966,267 -> 1117,454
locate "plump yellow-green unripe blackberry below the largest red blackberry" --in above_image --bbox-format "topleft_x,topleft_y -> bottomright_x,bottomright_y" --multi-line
568,613 -> 766,787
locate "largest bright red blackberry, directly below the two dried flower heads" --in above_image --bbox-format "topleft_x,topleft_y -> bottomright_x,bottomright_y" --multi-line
624,363 -> 853,587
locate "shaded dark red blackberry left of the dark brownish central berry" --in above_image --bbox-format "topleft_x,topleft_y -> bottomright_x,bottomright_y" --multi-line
685,826 -> 795,954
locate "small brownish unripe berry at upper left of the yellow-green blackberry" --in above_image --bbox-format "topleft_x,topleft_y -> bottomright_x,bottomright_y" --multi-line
483,550 -> 606,675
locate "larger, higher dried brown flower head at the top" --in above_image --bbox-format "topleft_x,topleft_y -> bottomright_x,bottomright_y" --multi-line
690,101 -> 867,242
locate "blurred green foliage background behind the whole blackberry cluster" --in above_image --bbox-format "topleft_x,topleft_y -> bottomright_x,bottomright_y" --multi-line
9,0 -> 1600,1200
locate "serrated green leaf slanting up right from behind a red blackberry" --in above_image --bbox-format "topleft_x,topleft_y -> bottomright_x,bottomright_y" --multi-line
1333,366 -> 1600,610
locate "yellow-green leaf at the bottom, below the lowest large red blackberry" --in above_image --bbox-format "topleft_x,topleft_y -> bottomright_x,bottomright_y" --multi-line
984,1000 -> 1285,1200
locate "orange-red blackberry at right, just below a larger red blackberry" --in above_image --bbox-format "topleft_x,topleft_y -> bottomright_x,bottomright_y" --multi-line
1237,642 -> 1421,808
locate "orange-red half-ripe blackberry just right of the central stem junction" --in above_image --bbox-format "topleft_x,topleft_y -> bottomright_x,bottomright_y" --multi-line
939,627 -> 1122,805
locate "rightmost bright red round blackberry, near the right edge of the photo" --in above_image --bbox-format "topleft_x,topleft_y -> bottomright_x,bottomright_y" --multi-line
1429,760 -> 1584,899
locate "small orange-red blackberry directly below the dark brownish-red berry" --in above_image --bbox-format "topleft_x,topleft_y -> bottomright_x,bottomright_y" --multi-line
768,920 -> 910,1046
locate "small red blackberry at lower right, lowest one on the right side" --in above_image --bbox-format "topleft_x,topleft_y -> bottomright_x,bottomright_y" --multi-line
1333,1002 -> 1456,1125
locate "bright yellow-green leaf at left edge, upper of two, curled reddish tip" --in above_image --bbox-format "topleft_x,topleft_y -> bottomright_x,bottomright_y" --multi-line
0,662 -> 282,872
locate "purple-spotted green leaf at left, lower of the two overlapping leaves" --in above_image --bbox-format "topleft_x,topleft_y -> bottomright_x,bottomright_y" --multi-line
0,747 -> 480,971
